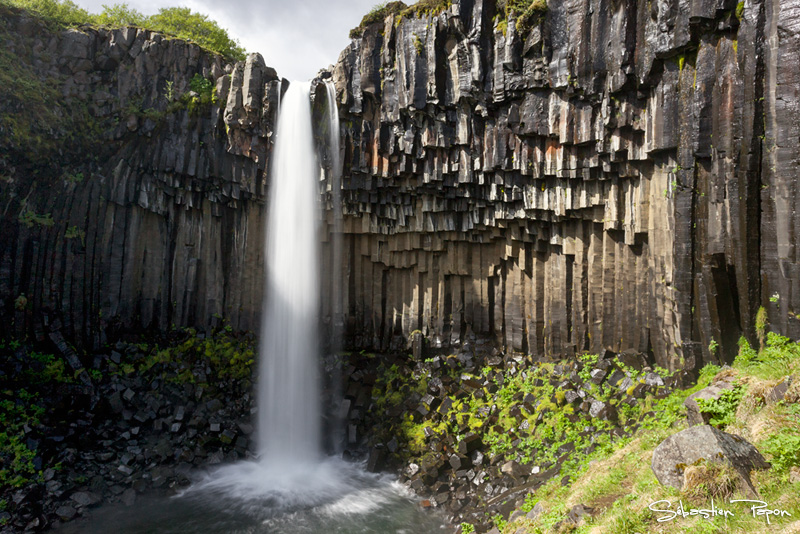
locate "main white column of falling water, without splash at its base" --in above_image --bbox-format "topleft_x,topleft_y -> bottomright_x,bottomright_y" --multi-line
258,82 -> 321,468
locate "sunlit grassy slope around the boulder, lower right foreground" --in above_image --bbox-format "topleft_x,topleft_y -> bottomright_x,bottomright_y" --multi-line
494,333 -> 800,534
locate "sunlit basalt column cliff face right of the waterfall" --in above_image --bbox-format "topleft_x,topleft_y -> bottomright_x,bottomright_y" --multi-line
334,0 -> 800,369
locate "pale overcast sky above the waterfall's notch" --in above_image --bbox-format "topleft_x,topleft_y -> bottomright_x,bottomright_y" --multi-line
75,0 -> 382,80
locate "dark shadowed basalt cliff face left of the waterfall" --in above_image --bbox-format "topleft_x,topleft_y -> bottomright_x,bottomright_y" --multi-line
0,12 -> 280,352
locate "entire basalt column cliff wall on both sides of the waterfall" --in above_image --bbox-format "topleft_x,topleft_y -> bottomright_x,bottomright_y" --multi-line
0,0 -> 800,369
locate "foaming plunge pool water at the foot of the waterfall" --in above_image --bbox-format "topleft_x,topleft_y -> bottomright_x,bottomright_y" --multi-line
57,458 -> 447,534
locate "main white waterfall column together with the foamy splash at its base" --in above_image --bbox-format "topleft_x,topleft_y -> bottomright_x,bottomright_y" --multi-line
187,82 -> 340,506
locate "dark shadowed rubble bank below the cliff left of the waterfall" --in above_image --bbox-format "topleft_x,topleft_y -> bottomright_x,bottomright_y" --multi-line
0,330 -> 254,533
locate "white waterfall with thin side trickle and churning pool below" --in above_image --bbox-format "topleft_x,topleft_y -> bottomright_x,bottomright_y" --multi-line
174,82 -> 438,534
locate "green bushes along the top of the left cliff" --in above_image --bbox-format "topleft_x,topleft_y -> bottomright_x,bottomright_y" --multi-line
0,0 -> 245,61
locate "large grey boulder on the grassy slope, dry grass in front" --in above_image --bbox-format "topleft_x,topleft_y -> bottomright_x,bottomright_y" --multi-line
651,425 -> 770,495
